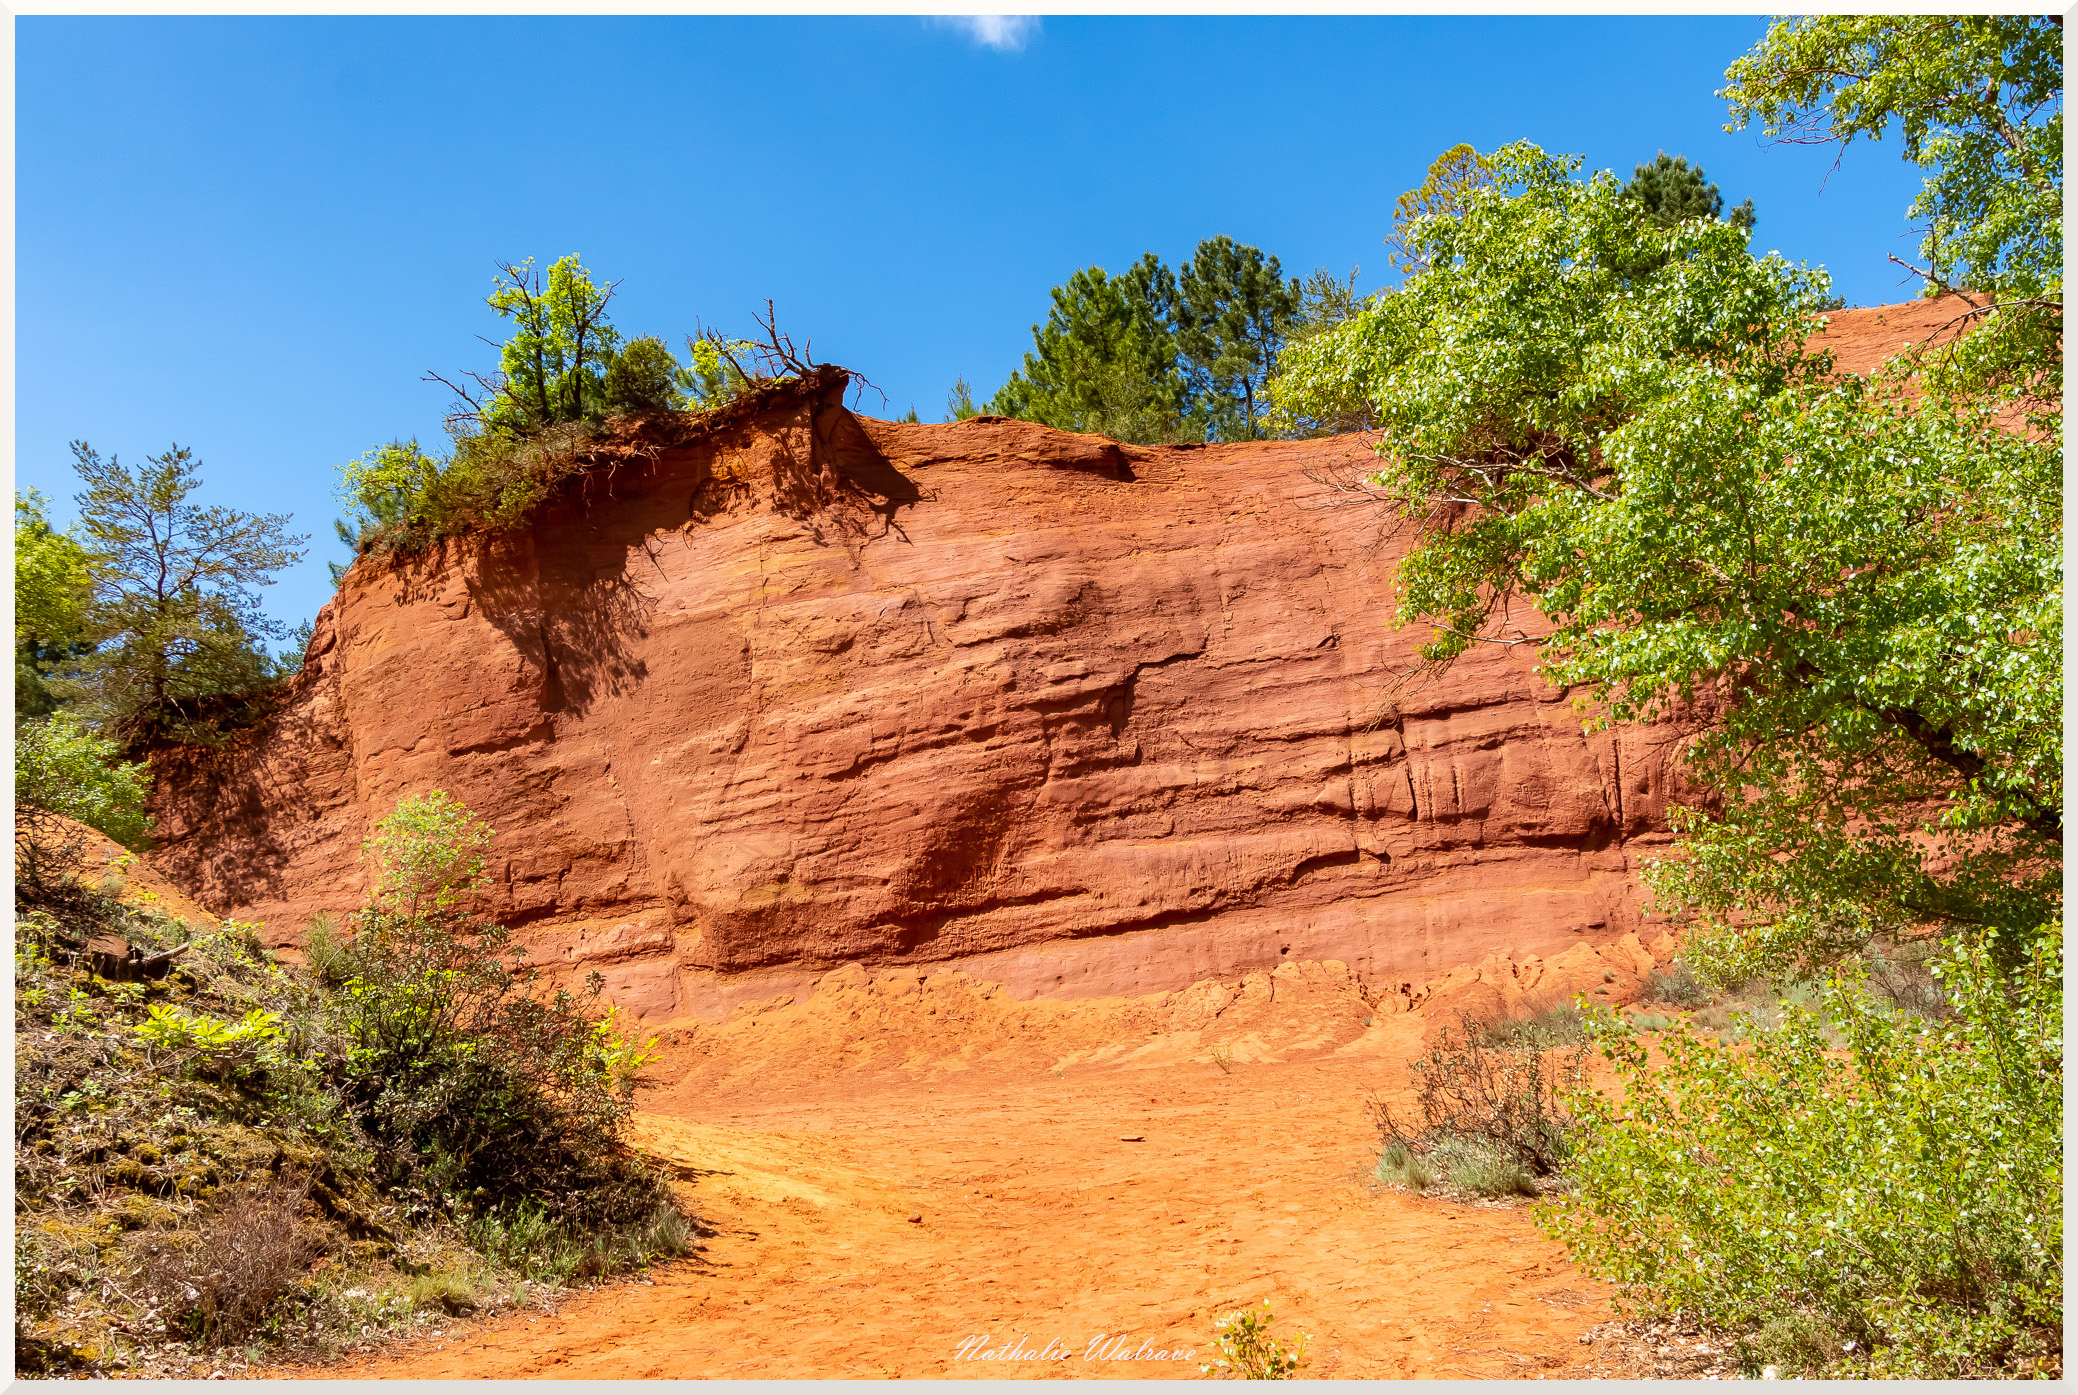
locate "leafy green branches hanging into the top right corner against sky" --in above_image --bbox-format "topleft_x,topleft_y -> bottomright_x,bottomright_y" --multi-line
1721,15 -> 2063,422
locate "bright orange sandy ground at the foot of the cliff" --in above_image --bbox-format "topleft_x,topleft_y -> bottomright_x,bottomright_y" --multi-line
297,956 -> 1670,1378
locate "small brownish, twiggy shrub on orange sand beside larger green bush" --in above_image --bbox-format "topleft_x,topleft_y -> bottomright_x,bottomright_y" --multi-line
1369,1015 -> 1588,1195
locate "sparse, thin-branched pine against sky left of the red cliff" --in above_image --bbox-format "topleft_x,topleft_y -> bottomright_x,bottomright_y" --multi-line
73,441 -> 308,740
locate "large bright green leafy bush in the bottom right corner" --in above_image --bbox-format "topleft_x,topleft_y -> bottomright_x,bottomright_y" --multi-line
1544,936 -> 2063,1378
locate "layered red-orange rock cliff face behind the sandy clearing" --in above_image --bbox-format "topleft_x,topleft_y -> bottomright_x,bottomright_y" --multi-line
156,389 -> 1703,1019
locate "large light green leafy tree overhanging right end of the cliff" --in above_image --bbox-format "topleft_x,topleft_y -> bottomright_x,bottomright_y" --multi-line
1278,136 -> 2061,975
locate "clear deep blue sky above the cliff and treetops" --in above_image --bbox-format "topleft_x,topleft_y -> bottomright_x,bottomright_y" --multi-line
15,17 -> 1918,624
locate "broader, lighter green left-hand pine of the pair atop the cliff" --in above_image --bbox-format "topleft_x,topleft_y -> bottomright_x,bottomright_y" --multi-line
989,252 -> 1201,443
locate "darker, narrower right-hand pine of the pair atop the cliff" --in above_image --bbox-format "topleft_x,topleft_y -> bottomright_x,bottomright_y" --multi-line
1171,233 -> 1301,441
